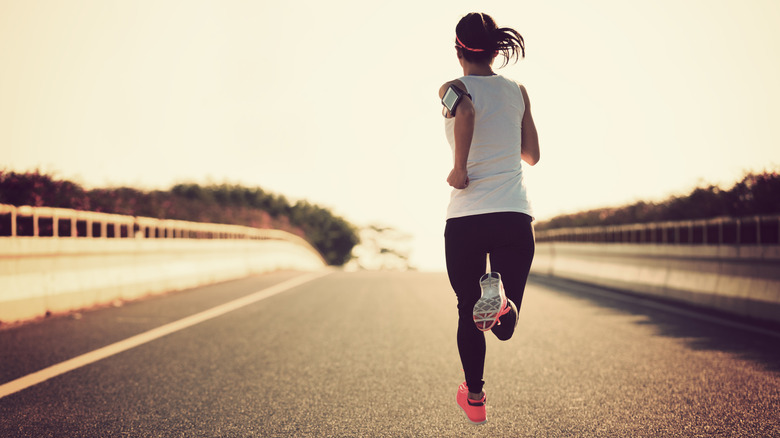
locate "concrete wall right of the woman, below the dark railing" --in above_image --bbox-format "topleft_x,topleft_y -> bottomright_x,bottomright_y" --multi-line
531,241 -> 780,323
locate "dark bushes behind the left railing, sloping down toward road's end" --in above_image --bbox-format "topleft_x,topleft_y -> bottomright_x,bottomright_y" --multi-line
0,171 -> 359,266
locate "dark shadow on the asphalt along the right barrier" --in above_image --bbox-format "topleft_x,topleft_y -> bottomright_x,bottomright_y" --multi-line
530,275 -> 780,373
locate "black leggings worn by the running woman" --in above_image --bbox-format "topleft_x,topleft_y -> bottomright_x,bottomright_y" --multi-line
444,212 -> 535,393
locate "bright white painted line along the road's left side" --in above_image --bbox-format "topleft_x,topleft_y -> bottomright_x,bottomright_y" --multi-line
0,270 -> 332,398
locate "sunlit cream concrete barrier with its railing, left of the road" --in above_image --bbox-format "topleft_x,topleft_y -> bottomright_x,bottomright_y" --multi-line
0,206 -> 325,323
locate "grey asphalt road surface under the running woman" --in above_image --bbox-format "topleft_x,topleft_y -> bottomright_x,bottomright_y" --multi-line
0,272 -> 780,437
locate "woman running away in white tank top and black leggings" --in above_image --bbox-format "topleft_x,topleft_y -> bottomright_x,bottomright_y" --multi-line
439,13 -> 539,423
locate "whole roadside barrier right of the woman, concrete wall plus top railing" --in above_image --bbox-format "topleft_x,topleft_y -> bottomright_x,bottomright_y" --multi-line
531,215 -> 780,324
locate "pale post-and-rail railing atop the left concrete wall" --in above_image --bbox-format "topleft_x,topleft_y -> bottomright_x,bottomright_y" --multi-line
0,204 -> 304,246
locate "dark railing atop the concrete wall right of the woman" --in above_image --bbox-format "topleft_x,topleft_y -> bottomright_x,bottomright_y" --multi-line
536,215 -> 780,245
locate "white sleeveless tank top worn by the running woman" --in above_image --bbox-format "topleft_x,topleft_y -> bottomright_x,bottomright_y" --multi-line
444,75 -> 533,219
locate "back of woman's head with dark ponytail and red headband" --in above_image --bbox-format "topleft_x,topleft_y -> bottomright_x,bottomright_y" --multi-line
455,12 -> 525,67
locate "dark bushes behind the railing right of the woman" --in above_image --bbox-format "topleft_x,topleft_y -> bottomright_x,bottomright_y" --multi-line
536,171 -> 780,230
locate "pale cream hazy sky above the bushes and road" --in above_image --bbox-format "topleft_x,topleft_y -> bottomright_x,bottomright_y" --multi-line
0,0 -> 780,269
